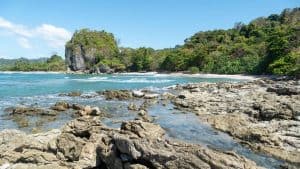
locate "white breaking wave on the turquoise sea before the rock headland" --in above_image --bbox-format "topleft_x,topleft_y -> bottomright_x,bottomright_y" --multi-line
71,77 -> 175,83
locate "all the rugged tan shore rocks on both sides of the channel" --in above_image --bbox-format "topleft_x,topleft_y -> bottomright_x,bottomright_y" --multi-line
0,79 -> 300,169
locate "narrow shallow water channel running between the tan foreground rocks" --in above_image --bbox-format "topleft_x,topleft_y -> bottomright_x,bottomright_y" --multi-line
149,104 -> 283,168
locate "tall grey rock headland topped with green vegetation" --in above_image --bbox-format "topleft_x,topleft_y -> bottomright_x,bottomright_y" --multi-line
65,29 -> 118,72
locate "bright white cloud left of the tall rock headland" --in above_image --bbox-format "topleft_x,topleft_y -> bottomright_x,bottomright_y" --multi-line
0,17 -> 72,49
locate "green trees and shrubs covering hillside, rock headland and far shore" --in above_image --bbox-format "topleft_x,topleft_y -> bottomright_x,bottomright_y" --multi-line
0,8 -> 300,76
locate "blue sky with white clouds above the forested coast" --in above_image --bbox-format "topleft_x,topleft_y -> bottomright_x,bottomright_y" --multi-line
0,0 -> 300,58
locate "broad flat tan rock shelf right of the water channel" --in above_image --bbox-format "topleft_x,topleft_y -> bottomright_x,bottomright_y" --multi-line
173,79 -> 300,166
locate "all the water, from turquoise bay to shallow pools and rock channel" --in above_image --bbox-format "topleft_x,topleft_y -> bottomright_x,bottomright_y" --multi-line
0,73 -> 281,168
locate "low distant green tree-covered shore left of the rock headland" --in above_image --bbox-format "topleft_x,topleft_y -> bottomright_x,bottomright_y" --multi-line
0,55 -> 66,71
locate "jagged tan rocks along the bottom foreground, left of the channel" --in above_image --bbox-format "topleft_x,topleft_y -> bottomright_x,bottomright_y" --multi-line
0,117 -> 260,169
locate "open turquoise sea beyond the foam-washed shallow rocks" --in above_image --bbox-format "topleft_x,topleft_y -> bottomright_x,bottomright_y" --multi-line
0,73 -> 237,98
